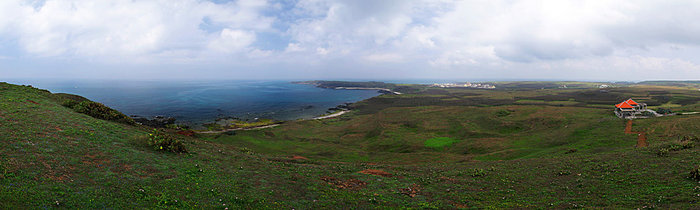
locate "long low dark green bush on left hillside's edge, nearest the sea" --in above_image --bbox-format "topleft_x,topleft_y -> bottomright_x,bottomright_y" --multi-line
72,100 -> 135,125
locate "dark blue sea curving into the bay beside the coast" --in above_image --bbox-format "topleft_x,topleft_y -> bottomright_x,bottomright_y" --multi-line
1,80 -> 380,125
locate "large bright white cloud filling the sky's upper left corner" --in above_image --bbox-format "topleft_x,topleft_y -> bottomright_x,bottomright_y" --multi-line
0,0 -> 273,59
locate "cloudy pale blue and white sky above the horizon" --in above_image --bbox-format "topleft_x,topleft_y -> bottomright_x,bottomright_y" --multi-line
0,0 -> 700,81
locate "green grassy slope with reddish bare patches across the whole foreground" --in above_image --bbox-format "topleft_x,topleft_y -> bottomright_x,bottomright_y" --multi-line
0,84 -> 700,208
